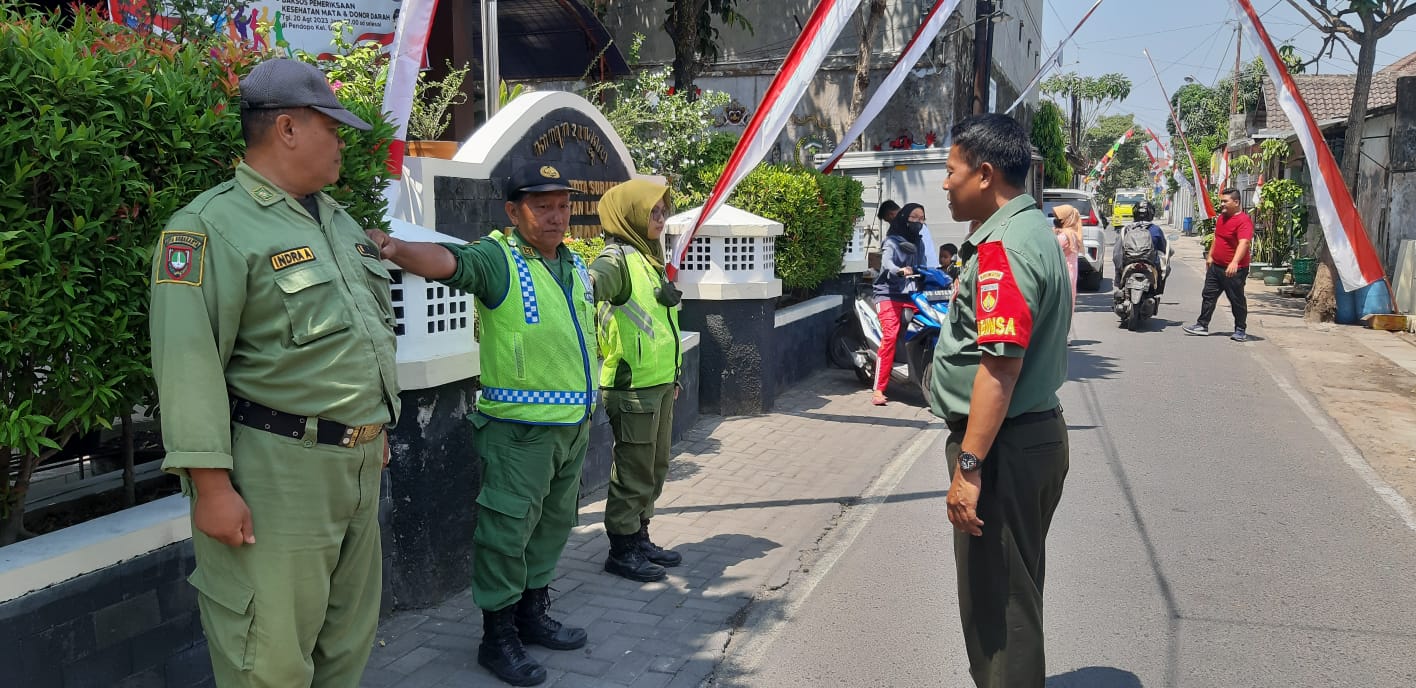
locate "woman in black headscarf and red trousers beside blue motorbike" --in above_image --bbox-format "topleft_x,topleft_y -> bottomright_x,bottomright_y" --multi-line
871,202 -> 925,406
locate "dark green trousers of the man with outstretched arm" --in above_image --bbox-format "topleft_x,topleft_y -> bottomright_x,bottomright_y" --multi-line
472,413 -> 590,612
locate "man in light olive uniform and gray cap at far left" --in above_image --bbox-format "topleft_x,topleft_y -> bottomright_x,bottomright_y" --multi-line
152,59 -> 398,688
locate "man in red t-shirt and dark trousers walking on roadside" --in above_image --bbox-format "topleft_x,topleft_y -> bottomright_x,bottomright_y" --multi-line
1182,188 -> 1253,341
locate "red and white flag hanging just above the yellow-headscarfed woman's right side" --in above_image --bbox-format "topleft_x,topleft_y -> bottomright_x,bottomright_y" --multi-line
668,0 -> 861,279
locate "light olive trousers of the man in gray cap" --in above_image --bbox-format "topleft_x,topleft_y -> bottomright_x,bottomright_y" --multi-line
190,425 -> 384,688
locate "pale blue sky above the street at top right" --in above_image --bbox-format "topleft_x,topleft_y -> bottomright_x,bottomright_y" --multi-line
1041,0 -> 1416,136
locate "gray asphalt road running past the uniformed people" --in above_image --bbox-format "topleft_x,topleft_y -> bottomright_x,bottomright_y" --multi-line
715,232 -> 1416,688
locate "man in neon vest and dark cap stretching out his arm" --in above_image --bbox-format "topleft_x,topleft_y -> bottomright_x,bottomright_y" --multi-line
368,164 -> 596,685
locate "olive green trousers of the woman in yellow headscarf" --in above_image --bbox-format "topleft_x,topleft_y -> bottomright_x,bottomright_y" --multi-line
603,382 -> 674,535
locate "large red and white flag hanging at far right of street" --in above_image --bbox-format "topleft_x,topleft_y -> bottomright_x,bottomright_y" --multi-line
1235,0 -> 1386,292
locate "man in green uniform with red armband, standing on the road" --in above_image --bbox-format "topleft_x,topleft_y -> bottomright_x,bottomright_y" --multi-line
929,115 -> 1072,688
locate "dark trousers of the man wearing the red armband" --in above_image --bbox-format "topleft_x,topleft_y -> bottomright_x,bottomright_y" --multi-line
944,413 -> 1068,688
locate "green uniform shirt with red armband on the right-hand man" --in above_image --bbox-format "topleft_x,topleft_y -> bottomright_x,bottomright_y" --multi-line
930,194 -> 1072,420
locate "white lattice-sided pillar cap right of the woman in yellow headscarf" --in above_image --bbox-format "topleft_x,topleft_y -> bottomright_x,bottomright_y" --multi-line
664,205 -> 783,300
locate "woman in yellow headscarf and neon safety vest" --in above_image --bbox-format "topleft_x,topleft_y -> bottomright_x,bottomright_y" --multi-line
589,180 -> 683,582
